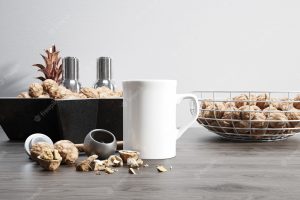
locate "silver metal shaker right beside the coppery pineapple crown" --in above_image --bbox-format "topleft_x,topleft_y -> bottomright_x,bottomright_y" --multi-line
62,57 -> 81,92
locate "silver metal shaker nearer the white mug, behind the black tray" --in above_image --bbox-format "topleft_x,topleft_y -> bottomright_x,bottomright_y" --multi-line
94,57 -> 115,90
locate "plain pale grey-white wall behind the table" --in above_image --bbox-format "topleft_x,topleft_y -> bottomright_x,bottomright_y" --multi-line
0,0 -> 300,125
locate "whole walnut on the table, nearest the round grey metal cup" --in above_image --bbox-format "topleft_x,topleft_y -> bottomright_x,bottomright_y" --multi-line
54,140 -> 79,165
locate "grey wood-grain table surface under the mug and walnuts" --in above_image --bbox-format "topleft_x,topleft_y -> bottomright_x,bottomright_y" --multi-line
0,128 -> 300,200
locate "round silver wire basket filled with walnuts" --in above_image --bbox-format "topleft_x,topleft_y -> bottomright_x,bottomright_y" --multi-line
193,91 -> 300,141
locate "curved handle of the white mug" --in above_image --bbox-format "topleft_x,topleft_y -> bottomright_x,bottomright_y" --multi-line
177,94 -> 199,139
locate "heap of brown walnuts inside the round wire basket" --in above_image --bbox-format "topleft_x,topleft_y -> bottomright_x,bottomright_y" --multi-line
198,94 -> 300,135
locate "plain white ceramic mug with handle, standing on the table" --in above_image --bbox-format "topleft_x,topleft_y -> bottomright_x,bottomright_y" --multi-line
123,80 -> 199,159
